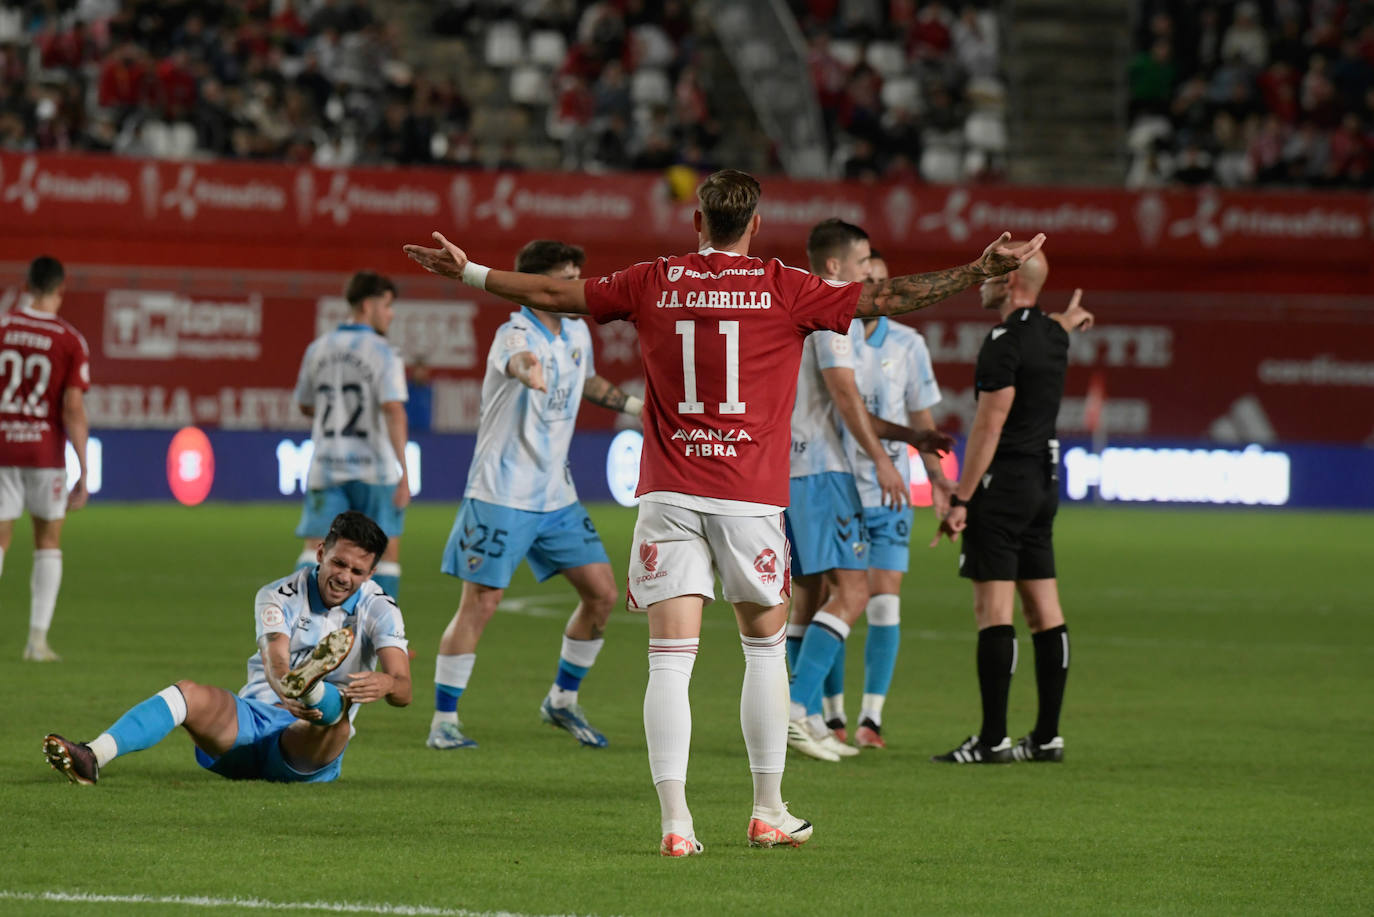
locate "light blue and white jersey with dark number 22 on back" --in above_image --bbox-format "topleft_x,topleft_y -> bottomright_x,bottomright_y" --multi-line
295,324 -> 405,491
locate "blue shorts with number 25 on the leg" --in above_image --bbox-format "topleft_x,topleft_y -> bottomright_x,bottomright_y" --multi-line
440,499 -> 610,588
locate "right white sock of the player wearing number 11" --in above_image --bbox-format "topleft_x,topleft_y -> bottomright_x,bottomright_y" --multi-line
739,628 -> 790,813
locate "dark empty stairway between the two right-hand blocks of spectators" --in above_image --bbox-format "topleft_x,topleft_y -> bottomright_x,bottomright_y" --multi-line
1003,0 -> 1131,187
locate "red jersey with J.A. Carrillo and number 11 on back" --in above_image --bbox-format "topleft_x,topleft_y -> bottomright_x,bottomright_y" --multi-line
585,249 -> 863,506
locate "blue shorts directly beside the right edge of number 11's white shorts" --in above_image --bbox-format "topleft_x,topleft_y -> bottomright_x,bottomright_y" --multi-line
787,472 -> 868,576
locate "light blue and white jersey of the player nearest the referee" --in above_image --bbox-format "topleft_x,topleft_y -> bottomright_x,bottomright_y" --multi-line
845,316 -> 940,506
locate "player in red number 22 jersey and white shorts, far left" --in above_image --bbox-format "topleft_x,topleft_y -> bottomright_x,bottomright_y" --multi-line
0,256 -> 91,663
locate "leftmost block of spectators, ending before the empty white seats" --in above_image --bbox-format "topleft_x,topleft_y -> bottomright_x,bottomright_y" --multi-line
0,0 -> 467,165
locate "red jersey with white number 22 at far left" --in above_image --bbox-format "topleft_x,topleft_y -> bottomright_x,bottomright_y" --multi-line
0,309 -> 91,467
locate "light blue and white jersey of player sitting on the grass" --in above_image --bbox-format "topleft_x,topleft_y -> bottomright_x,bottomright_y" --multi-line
239,565 -> 408,720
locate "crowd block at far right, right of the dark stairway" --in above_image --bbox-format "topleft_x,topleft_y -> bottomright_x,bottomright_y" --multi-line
1127,0 -> 1374,188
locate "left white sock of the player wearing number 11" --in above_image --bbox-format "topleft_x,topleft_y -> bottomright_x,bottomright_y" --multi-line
644,638 -> 698,837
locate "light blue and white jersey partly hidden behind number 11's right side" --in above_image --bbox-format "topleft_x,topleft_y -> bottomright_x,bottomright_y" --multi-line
790,324 -> 855,477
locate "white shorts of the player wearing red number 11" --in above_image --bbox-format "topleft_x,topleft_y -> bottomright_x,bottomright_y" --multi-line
627,502 -> 791,610
